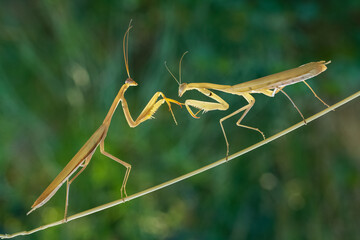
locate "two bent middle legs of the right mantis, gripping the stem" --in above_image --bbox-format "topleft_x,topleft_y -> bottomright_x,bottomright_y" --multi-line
219,94 -> 265,160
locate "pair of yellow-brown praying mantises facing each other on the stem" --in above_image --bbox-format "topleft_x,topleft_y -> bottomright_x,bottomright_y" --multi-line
27,23 -> 330,221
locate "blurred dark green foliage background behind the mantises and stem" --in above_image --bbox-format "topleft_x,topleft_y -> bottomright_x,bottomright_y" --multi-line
0,0 -> 360,240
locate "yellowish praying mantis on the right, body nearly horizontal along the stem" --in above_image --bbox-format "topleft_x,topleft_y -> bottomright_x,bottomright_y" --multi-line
165,52 -> 331,159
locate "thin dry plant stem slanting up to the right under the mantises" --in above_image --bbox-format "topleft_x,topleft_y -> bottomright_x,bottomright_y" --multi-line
0,91 -> 360,239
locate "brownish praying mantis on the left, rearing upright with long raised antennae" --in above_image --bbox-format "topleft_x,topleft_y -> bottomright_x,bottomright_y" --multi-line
27,22 -> 181,222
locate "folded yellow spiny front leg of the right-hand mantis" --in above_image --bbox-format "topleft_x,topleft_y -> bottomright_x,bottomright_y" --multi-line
185,88 -> 229,118
